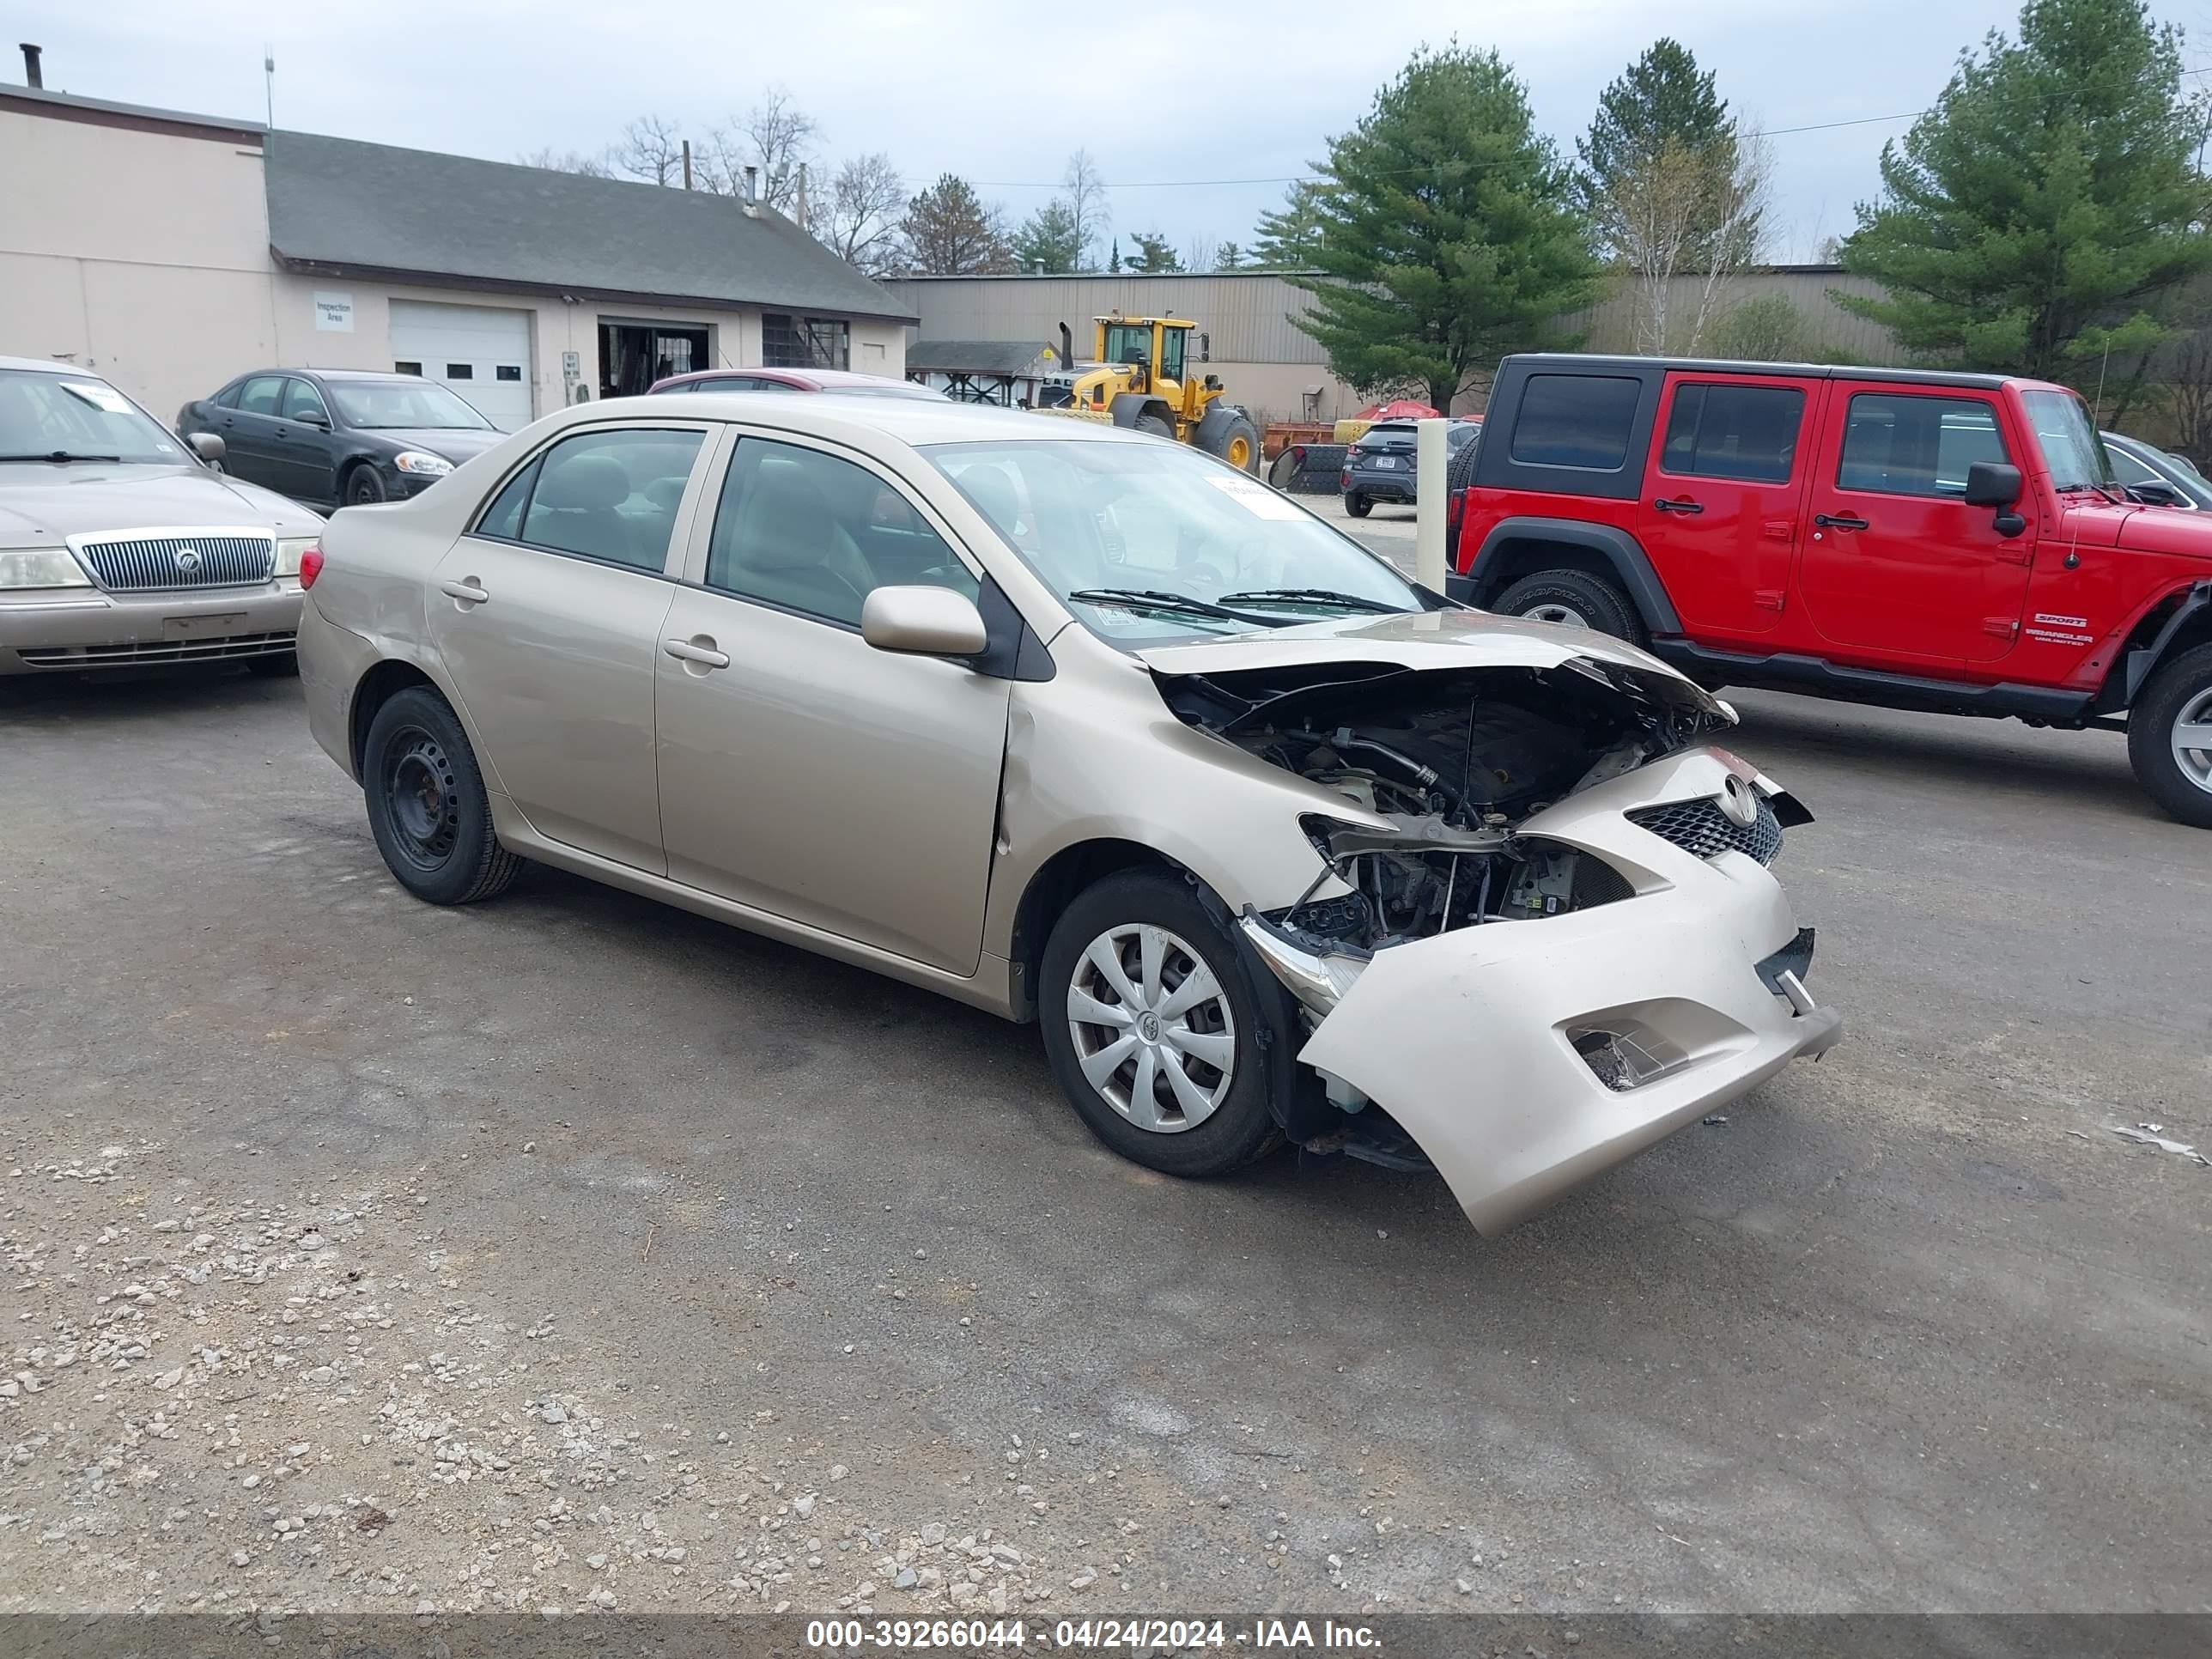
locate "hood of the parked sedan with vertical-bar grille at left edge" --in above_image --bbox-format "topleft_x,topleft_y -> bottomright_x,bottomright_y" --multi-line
0,462 -> 323,549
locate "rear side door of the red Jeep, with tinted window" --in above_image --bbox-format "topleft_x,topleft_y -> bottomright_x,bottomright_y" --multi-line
1637,374 -> 1812,639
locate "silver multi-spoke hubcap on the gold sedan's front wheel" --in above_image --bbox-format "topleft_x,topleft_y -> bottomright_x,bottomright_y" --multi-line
1068,922 -> 1237,1134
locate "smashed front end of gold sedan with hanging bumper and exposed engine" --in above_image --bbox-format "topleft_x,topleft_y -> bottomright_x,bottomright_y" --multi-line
1155,654 -> 1840,1232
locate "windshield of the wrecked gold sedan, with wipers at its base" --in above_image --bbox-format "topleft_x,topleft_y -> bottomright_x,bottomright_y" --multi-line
922,438 -> 1425,646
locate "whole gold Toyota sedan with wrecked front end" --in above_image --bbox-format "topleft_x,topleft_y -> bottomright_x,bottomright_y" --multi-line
299,394 -> 1840,1232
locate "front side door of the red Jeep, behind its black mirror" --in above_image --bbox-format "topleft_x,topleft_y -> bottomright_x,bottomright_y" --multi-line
1796,380 -> 2037,665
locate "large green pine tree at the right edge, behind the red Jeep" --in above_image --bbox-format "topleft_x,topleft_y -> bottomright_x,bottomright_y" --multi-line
1836,0 -> 2212,378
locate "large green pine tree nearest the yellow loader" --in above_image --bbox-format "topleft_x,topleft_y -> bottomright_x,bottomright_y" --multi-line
1291,46 -> 1599,410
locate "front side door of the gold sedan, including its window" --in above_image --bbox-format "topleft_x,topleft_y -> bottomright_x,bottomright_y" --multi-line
659,431 -> 1009,973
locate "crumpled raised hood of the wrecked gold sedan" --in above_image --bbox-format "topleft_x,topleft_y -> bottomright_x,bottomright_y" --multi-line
1137,608 -> 1690,684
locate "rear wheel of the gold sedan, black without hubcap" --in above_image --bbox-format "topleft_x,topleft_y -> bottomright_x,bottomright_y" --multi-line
361,686 -> 522,905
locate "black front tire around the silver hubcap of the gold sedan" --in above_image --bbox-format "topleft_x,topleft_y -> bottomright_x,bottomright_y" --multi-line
1037,869 -> 1298,1179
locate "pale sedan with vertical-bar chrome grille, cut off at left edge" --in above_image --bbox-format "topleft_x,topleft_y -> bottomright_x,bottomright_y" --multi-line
0,356 -> 323,675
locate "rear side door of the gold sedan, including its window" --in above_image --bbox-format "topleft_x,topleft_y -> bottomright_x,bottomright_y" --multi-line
422,420 -> 717,876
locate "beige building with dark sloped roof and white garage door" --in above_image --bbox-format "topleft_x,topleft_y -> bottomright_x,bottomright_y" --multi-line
0,86 -> 914,429
